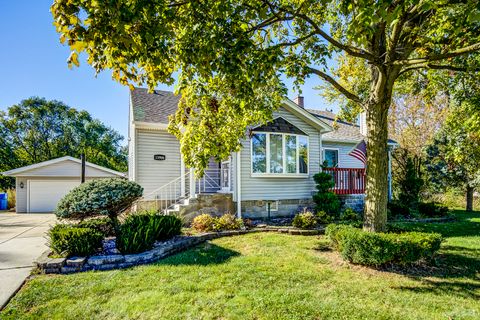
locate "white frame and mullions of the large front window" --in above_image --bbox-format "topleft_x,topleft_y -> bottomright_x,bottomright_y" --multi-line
250,131 -> 311,178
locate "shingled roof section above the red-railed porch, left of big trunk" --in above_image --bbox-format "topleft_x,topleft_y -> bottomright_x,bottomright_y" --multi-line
307,109 -> 365,142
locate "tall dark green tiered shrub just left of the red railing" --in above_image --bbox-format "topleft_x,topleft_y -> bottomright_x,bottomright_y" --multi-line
313,172 -> 340,216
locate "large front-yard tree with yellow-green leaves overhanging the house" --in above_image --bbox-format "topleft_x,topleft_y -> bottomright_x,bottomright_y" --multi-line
52,0 -> 480,231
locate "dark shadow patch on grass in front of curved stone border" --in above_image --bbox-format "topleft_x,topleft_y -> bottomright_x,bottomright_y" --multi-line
157,243 -> 240,266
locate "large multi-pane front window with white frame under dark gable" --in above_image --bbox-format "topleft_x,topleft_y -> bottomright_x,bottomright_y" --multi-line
251,132 -> 308,175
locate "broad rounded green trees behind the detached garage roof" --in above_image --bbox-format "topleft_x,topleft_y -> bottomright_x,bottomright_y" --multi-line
0,98 -> 127,188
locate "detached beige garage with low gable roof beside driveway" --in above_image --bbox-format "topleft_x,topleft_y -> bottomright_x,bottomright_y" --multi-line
3,156 -> 124,212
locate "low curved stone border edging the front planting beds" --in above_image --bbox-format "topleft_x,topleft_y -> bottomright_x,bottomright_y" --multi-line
35,227 -> 325,274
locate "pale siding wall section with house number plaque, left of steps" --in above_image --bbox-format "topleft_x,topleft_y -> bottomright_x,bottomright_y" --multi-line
135,129 -> 180,195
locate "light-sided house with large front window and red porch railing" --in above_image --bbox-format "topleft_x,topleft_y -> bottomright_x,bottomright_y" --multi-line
128,88 -> 394,217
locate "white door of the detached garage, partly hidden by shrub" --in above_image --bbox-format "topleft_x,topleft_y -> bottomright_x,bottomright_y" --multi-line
28,180 -> 80,212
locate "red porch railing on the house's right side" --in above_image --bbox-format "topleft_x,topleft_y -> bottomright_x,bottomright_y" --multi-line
323,168 -> 365,194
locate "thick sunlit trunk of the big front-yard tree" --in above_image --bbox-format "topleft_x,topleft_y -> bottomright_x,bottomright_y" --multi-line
363,67 -> 394,232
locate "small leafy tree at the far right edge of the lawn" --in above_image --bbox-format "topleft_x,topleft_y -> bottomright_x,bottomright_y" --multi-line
426,104 -> 480,211
